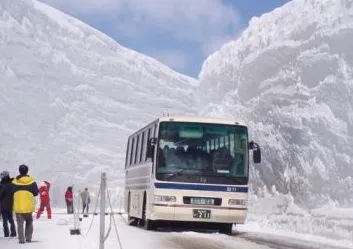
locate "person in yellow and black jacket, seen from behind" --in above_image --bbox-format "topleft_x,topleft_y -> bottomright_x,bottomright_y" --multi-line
12,164 -> 39,244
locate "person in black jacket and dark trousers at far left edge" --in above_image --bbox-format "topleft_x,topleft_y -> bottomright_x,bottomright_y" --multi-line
0,171 -> 16,237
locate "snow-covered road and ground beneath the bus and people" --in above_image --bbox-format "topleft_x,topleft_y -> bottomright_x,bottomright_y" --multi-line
0,209 -> 350,249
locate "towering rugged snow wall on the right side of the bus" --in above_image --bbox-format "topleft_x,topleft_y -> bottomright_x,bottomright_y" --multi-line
198,0 -> 353,207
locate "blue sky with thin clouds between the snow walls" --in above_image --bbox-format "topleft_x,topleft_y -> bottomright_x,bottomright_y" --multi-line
41,0 -> 289,77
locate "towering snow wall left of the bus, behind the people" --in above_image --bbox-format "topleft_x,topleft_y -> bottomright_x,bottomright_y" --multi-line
0,0 -> 196,198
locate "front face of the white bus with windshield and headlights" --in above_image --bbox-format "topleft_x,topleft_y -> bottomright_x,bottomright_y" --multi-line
150,118 -> 260,233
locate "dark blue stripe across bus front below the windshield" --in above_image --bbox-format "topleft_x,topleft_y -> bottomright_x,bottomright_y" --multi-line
154,182 -> 248,193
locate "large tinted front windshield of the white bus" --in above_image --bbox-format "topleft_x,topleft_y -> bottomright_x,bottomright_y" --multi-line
156,122 -> 248,184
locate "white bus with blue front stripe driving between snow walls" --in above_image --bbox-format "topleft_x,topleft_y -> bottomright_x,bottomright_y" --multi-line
125,116 -> 261,234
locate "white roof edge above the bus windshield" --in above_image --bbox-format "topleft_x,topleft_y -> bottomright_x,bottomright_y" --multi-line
159,116 -> 246,126
